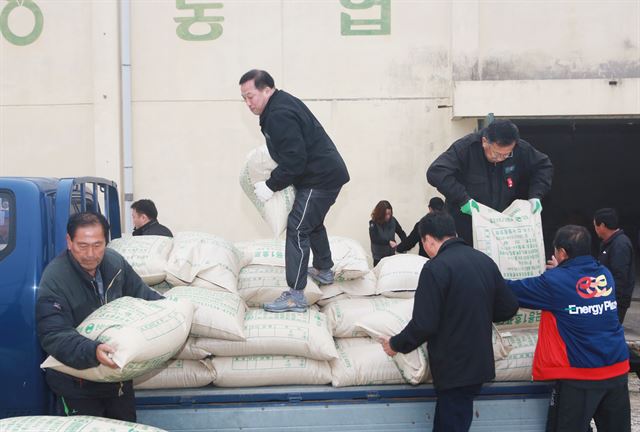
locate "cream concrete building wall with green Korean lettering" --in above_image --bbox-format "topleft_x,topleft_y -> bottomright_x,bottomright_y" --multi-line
0,0 -> 640,253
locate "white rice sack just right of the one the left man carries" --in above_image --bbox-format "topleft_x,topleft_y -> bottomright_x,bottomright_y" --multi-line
166,286 -> 246,340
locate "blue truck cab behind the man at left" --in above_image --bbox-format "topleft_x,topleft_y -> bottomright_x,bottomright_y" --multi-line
0,177 -> 121,418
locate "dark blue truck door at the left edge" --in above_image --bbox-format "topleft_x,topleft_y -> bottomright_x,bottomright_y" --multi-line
0,182 -> 48,418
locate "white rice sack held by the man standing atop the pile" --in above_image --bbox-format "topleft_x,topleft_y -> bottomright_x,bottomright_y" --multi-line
240,144 -> 296,237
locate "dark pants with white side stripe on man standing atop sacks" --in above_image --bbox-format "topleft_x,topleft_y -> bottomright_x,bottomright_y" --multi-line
285,189 -> 340,290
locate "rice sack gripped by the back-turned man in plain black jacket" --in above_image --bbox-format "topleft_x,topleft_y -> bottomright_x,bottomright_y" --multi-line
355,300 -> 429,385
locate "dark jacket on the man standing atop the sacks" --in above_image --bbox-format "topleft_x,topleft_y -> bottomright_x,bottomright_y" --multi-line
260,90 -> 349,191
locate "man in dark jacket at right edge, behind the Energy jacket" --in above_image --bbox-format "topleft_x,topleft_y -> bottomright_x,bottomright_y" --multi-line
593,208 -> 636,324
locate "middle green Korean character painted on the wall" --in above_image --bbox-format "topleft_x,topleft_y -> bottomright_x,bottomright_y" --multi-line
173,0 -> 224,41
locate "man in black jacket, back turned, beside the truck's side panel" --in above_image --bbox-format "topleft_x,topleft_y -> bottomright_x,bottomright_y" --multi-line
383,212 -> 518,432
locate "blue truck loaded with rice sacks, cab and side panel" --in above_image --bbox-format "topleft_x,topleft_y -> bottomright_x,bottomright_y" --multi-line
0,177 -> 550,432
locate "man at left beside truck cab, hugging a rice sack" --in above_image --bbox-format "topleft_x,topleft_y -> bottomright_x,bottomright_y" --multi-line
36,212 -> 163,422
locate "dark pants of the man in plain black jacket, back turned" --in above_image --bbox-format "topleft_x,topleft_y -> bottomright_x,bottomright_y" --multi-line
433,384 -> 482,432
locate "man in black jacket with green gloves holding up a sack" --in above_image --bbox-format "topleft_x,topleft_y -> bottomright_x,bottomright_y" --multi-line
427,120 -> 553,244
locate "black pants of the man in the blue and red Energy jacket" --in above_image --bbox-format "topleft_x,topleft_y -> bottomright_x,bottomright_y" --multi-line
547,374 -> 631,432
